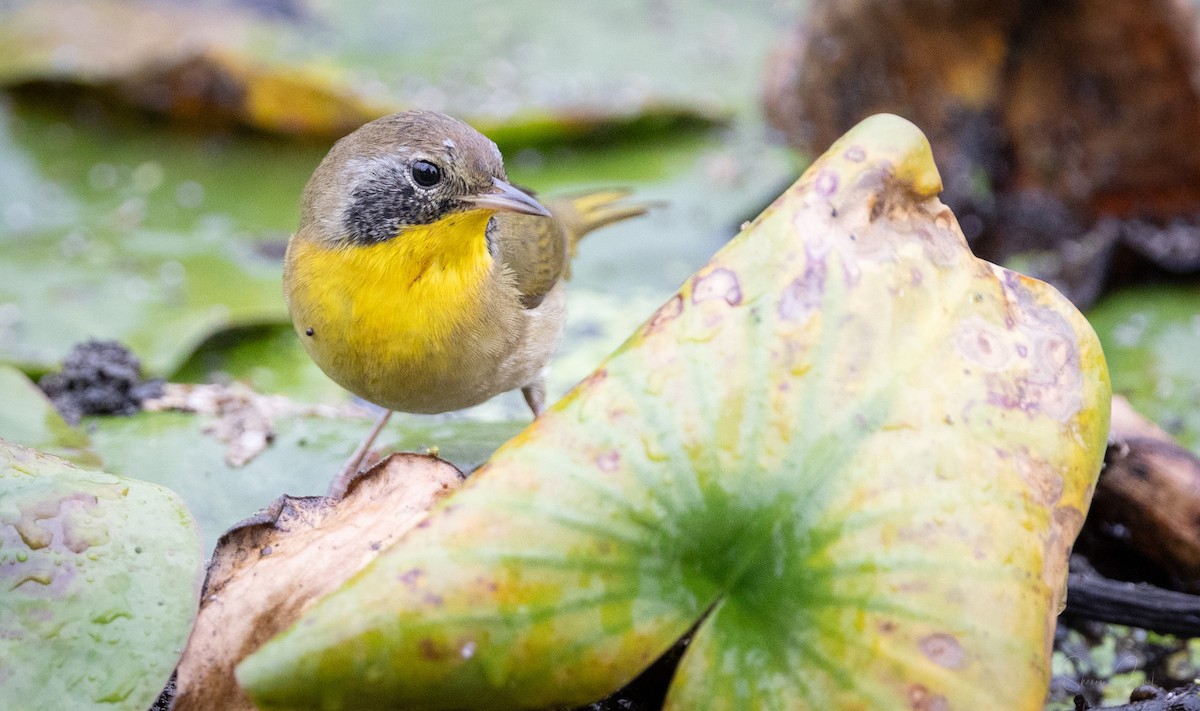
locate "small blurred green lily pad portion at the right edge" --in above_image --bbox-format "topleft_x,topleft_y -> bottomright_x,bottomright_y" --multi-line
1087,286 -> 1200,453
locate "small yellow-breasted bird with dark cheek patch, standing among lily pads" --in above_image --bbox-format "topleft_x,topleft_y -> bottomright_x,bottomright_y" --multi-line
283,110 -> 647,494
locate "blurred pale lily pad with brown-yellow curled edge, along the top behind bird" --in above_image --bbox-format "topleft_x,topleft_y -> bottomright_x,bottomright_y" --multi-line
0,0 -> 792,140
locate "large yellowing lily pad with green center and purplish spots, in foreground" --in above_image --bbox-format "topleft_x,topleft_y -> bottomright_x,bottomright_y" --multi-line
238,116 -> 1109,710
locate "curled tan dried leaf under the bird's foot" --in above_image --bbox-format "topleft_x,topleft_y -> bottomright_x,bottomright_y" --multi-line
174,454 -> 462,711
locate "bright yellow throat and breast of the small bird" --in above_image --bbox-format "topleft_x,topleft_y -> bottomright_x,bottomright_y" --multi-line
283,210 -> 492,408
